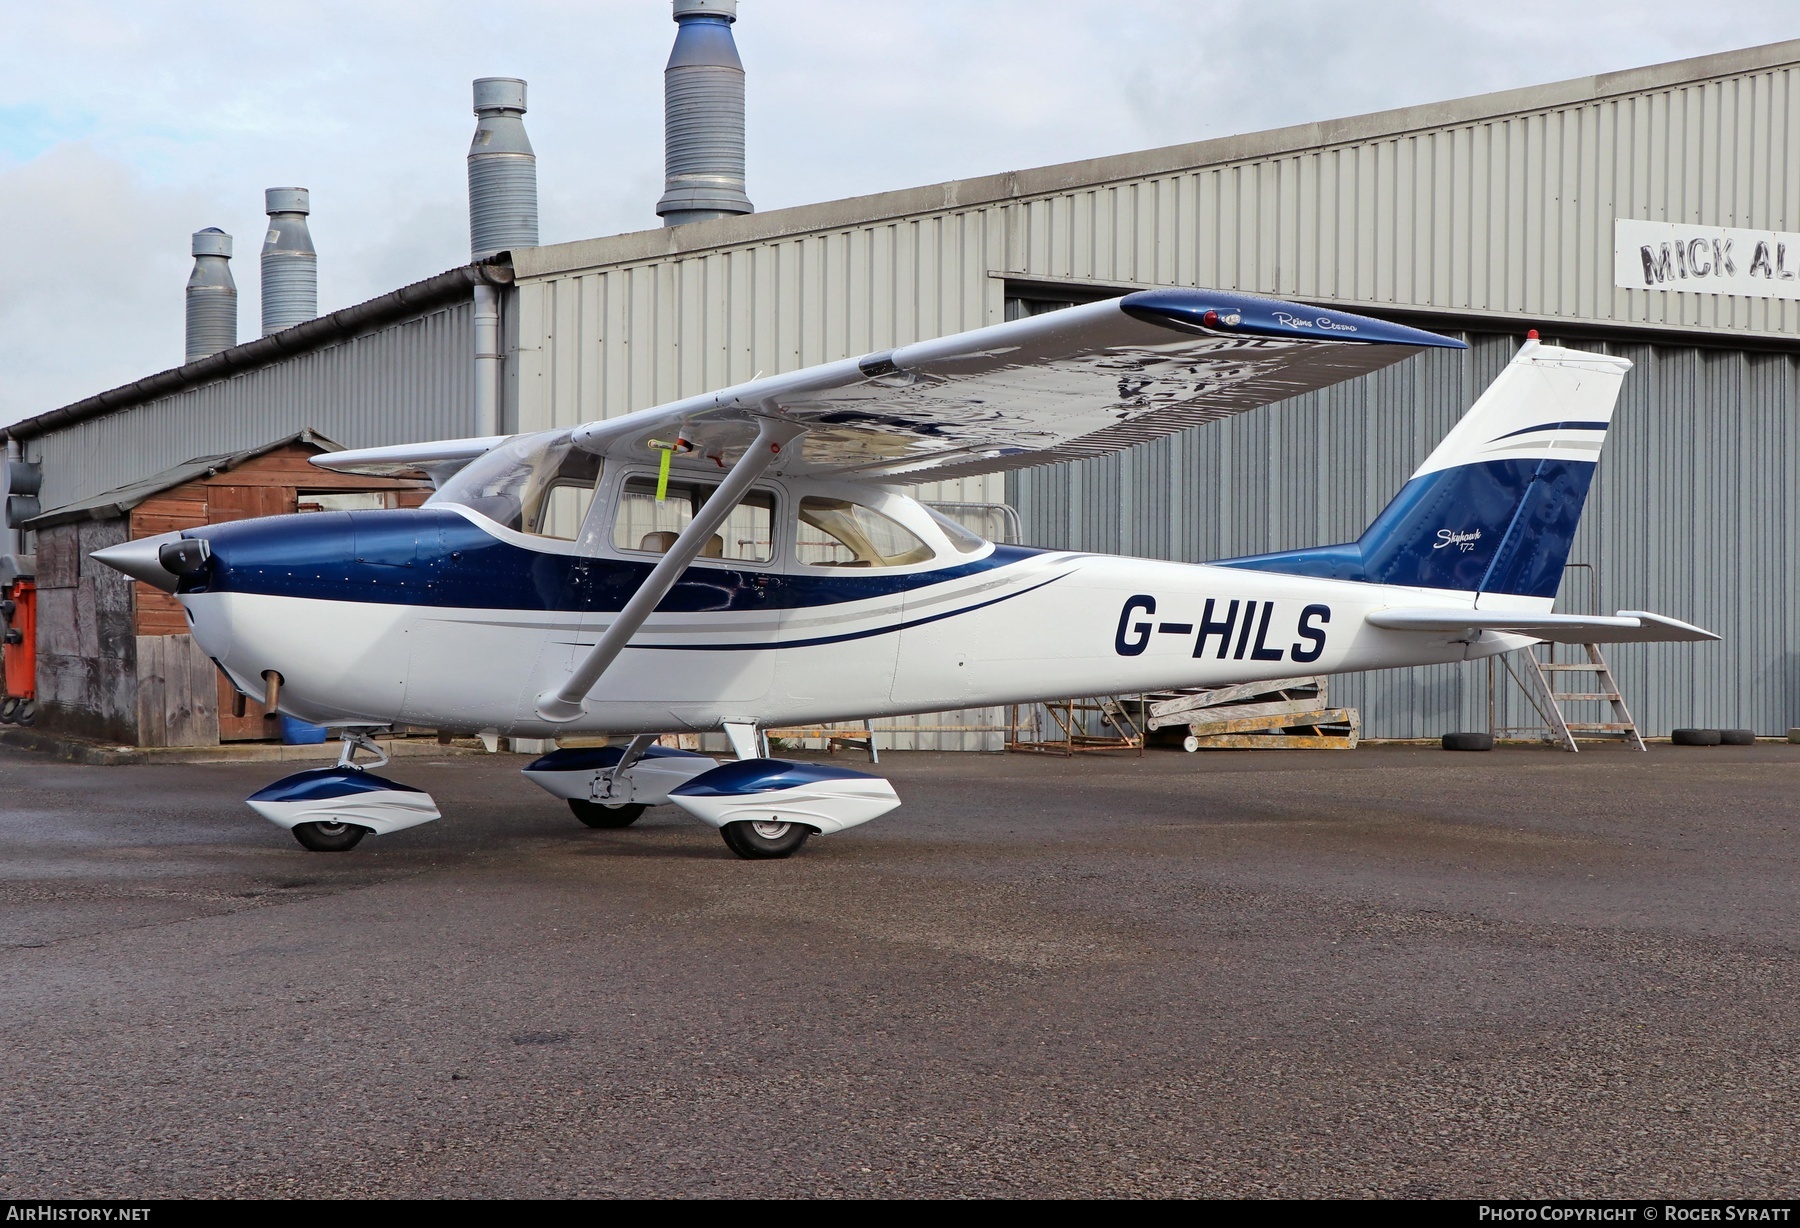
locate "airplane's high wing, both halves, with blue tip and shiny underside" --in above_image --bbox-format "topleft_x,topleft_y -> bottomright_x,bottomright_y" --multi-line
320,290 -> 1463,483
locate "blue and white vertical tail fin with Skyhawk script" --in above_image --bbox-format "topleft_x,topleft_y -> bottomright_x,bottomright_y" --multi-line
1222,340 -> 1631,600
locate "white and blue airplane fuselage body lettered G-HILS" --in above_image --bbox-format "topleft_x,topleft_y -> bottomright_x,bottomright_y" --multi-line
178,471 -> 1528,736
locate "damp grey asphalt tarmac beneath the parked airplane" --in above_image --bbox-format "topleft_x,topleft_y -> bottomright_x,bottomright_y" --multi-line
0,744 -> 1800,1197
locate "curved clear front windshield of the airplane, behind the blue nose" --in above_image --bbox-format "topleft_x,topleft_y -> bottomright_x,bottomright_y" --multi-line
427,430 -> 599,540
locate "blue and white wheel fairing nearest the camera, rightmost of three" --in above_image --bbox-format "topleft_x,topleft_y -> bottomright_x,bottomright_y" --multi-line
670,760 -> 900,835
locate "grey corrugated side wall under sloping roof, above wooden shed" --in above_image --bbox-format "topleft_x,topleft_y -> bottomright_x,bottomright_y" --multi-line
25,302 -> 475,508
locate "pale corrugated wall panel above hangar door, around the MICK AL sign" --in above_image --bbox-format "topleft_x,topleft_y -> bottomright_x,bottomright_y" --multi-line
1003,65 -> 1800,333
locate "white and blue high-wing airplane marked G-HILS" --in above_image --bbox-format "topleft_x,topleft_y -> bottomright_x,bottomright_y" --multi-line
94,290 -> 1715,859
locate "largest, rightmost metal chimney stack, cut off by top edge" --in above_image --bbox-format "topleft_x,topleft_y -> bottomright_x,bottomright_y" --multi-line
657,0 -> 754,227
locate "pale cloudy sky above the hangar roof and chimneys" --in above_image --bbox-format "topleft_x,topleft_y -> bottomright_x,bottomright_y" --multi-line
0,0 -> 1800,423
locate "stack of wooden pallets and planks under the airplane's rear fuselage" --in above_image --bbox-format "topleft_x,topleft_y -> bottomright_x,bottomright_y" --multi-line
1143,675 -> 1361,751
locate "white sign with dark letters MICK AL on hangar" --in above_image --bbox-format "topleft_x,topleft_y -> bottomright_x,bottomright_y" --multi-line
1613,218 -> 1800,299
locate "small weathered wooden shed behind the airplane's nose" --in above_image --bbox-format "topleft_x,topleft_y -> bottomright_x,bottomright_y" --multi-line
29,430 -> 430,745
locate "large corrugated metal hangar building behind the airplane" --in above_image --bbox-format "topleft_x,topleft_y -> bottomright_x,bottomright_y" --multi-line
0,9 -> 1800,749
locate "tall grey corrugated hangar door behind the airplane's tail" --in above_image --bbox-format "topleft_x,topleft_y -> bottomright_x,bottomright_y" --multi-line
1008,335 -> 1800,738
